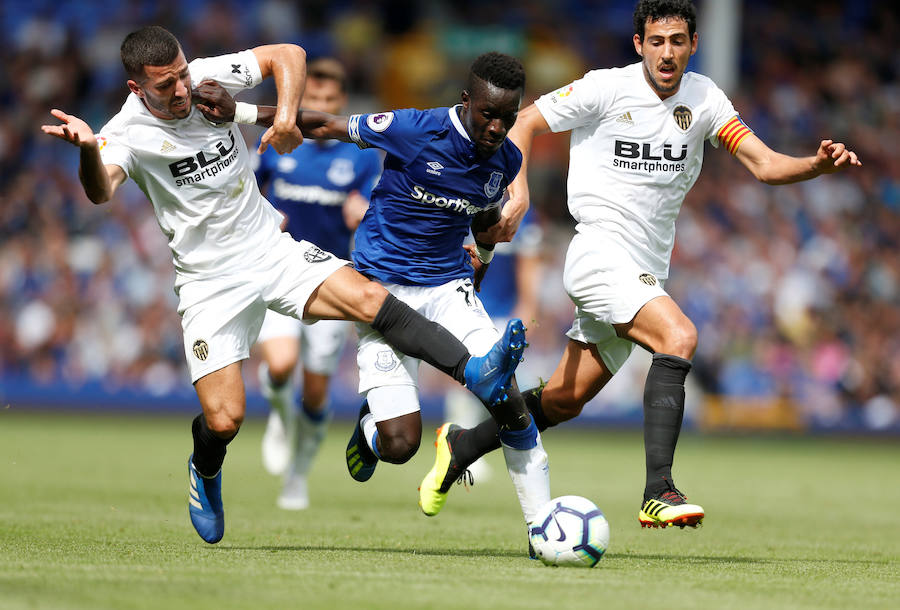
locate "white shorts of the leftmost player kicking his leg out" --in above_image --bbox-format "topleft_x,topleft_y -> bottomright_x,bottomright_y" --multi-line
176,233 -> 350,383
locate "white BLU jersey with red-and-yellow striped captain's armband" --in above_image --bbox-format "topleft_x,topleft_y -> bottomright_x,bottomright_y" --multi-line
535,63 -> 749,279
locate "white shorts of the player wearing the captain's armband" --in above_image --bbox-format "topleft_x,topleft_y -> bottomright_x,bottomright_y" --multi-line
563,226 -> 666,374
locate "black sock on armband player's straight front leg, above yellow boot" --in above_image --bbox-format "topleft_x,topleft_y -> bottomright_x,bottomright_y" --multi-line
644,354 -> 691,498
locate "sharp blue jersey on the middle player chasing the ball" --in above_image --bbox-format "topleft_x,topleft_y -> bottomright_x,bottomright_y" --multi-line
348,107 -> 522,286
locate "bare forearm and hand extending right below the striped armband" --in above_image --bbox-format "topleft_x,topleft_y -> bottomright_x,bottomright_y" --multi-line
734,133 -> 862,184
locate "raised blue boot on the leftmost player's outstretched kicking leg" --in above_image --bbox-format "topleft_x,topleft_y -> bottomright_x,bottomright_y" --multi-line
465,318 -> 528,407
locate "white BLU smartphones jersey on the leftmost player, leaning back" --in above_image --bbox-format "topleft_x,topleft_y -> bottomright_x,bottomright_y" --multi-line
98,51 -> 281,287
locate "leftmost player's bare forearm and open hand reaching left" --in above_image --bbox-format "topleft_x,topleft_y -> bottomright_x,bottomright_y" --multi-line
41,108 -> 125,203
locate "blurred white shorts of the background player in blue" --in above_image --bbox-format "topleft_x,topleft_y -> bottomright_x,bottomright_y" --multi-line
257,309 -> 352,376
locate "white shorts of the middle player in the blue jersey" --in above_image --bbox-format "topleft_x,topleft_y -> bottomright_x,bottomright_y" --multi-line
356,279 -> 500,421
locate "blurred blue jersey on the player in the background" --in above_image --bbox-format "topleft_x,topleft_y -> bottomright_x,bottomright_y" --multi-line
256,140 -> 381,258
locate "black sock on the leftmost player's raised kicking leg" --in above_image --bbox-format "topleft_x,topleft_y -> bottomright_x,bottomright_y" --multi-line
372,294 -> 469,384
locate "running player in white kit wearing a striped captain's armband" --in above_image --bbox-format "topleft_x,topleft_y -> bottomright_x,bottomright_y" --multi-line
420,0 -> 861,528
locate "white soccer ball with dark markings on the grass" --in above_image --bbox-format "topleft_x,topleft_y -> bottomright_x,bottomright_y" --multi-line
528,496 -> 609,568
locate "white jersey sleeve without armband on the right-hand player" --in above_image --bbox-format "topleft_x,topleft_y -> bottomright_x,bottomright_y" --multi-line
534,70 -> 613,132
